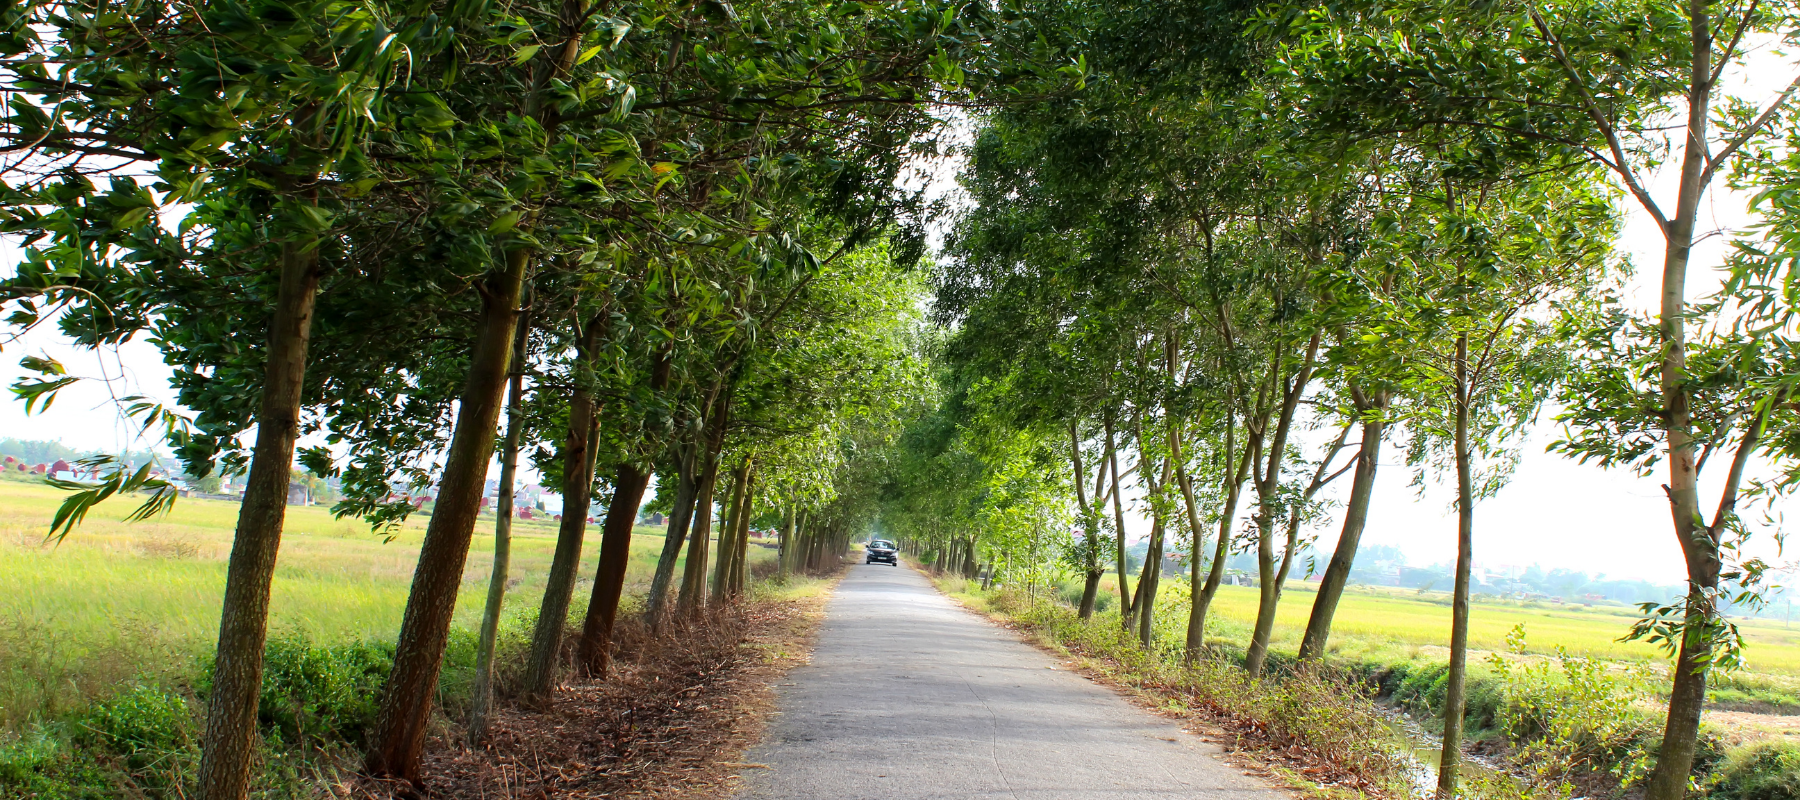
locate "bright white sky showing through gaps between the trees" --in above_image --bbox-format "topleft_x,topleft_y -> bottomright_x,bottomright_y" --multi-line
0,49 -> 1793,584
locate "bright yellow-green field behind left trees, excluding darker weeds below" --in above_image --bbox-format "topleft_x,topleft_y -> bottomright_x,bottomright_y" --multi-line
0,481 -> 772,730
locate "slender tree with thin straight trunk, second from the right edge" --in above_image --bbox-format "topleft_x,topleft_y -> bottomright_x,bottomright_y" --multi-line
1388,167 -> 1613,798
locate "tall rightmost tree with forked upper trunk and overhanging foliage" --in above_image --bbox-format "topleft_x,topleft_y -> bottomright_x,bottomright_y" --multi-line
1260,0 -> 1800,789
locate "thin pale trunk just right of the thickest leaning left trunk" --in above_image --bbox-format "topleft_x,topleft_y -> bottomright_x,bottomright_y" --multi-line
468,312 -> 531,746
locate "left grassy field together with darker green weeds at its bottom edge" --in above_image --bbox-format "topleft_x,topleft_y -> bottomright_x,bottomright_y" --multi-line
0,481 -> 788,796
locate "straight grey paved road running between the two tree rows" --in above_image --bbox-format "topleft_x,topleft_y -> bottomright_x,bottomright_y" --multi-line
738,564 -> 1287,800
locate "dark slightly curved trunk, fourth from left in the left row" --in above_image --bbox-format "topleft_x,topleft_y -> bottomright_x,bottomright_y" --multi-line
522,335 -> 599,708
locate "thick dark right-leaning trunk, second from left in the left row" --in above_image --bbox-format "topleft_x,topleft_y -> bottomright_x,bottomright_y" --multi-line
367,247 -> 531,782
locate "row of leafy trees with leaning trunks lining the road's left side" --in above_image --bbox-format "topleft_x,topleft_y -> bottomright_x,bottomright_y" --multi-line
0,0 -> 1078,800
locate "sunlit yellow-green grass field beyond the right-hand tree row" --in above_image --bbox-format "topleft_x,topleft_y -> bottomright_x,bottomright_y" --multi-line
1000,582 -> 1800,798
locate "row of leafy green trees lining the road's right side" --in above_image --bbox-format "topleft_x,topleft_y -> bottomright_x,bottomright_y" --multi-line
884,0 -> 1800,800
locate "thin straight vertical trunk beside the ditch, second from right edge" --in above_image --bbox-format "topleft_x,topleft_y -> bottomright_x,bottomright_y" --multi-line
1438,333 -> 1474,800
